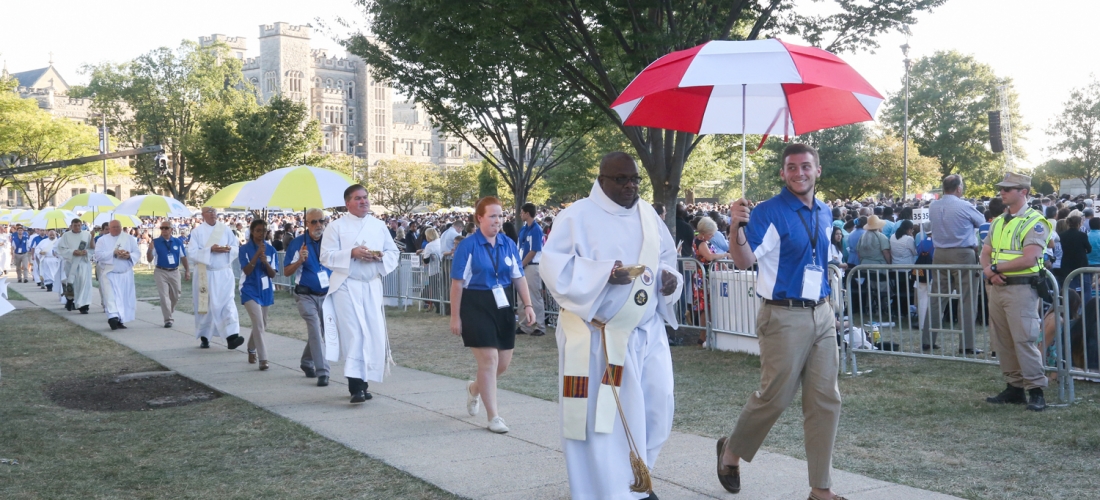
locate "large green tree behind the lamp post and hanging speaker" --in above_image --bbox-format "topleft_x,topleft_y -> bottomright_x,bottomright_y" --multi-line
884,51 -> 1027,186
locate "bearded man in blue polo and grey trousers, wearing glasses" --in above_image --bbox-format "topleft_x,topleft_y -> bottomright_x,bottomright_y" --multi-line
283,209 -> 332,387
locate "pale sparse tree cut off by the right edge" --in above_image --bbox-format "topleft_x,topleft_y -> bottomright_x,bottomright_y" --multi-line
1047,78 -> 1100,196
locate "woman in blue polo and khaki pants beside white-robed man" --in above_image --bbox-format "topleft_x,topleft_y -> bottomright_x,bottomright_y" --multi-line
238,219 -> 278,370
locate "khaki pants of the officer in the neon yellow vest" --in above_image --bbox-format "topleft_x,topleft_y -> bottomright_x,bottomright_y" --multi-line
988,285 -> 1046,389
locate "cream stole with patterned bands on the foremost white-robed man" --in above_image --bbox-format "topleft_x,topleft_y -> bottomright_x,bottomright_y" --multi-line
558,200 -> 661,441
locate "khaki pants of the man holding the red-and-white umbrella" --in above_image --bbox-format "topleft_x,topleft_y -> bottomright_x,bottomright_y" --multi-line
726,303 -> 840,488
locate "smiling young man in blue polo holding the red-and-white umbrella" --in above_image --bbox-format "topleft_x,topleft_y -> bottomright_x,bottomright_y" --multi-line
717,144 -> 840,500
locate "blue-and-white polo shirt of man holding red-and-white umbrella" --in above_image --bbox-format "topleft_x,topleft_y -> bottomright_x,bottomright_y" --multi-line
745,187 -> 833,300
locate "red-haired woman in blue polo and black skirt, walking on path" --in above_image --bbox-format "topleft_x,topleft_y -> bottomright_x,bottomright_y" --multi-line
451,197 -> 535,434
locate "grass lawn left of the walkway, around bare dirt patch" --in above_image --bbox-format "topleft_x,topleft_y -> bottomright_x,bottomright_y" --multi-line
0,310 -> 457,499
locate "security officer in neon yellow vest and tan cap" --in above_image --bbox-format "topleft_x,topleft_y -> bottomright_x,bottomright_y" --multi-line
981,171 -> 1052,411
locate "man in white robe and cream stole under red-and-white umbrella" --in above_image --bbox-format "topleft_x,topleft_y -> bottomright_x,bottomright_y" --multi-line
539,153 -> 683,500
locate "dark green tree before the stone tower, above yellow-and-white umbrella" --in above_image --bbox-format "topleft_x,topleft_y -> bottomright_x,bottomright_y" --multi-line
184,96 -> 320,186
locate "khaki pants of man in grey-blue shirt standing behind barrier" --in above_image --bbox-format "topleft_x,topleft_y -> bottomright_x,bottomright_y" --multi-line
921,247 -> 980,349
